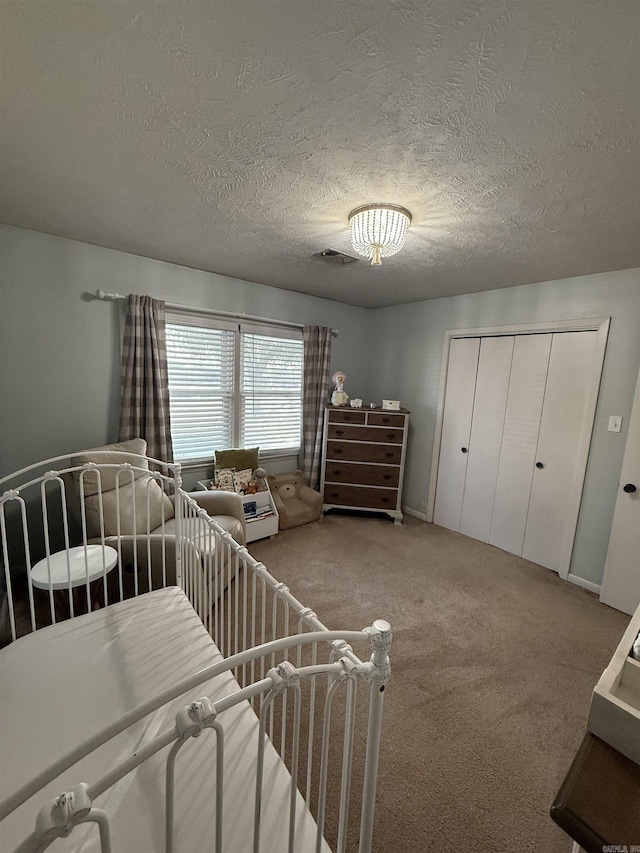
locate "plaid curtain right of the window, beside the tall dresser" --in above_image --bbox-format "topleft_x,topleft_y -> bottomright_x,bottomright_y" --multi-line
302,326 -> 331,489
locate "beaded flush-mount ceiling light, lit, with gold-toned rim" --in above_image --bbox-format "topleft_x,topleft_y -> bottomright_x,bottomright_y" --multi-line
349,204 -> 411,267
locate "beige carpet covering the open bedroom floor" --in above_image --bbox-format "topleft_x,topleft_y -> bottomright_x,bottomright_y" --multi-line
250,514 -> 629,853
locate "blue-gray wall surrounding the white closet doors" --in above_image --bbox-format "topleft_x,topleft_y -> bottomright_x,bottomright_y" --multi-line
367,270 -> 640,584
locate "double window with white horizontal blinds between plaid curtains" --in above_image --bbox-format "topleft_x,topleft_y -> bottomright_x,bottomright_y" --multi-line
166,311 -> 303,460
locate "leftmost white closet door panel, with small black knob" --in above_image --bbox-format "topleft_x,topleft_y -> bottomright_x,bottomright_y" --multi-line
433,338 -> 480,530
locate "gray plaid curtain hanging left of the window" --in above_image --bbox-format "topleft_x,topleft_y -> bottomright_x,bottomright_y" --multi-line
118,293 -> 173,462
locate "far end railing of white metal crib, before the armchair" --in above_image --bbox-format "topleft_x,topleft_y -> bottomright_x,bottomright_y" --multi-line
0,452 -> 185,644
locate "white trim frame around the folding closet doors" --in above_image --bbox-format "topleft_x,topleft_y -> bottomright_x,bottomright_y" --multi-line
426,317 -> 611,580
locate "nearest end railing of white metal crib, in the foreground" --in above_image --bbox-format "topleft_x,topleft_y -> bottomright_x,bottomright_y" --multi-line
0,622 -> 390,853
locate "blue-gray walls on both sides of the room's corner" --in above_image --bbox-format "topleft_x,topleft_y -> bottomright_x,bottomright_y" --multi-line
0,226 -> 640,584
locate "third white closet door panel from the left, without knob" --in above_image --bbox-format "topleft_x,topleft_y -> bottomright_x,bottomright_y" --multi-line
489,334 -> 552,554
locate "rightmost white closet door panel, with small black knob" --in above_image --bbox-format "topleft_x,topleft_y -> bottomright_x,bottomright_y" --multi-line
522,332 -> 597,571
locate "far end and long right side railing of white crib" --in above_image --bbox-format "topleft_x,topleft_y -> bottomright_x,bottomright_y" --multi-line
0,453 -> 391,853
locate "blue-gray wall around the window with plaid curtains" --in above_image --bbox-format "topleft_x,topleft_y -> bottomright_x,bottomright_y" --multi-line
0,226 -> 368,487
